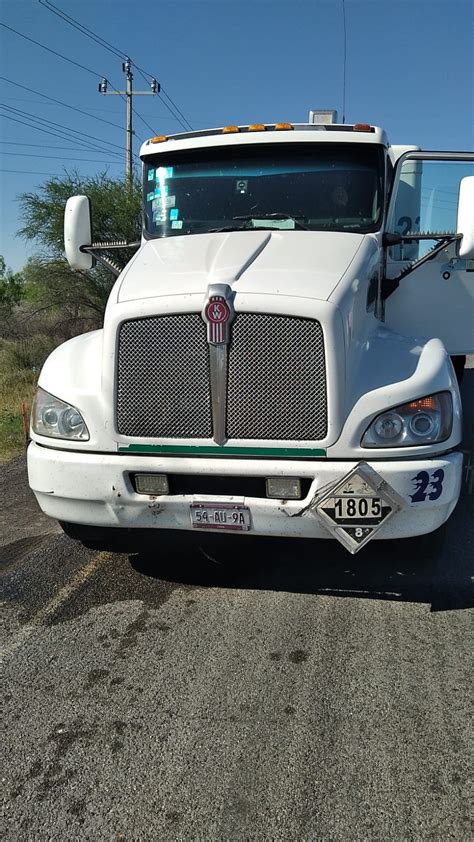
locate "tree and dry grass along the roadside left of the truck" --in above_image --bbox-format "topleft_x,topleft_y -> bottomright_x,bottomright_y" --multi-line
0,173 -> 141,462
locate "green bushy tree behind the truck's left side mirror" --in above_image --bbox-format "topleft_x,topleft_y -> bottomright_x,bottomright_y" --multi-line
18,172 -> 141,336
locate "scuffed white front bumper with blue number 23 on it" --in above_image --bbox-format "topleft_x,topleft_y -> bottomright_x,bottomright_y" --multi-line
28,442 -> 462,539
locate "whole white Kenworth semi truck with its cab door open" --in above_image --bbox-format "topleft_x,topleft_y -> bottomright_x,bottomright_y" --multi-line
28,112 -> 474,553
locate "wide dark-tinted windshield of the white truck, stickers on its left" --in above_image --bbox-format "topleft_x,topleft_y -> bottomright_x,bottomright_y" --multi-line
144,142 -> 383,237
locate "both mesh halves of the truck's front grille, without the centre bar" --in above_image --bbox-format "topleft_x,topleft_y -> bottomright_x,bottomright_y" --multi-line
117,313 -> 327,441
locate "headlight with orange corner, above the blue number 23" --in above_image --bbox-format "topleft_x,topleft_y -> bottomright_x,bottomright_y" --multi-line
361,392 -> 453,447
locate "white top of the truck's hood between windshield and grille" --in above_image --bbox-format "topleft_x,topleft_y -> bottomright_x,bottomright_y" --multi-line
117,230 -> 364,302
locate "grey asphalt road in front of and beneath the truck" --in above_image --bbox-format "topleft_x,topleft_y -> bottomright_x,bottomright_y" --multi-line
0,364 -> 474,840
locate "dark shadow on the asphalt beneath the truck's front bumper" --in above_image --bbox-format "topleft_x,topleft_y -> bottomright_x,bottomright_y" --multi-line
129,498 -> 474,611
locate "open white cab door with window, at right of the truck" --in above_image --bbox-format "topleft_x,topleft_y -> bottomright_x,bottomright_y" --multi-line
382,152 -> 474,355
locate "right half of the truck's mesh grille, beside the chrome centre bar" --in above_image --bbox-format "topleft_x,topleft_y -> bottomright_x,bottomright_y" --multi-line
227,313 -> 327,441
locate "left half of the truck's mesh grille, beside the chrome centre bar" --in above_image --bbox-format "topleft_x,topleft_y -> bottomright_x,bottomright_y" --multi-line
117,313 -> 212,438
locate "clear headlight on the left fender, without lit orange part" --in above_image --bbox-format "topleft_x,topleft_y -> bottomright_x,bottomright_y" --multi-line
31,388 -> 89,441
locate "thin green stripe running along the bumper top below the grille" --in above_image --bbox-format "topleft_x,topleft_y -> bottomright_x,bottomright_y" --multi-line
118,444 -> 326,459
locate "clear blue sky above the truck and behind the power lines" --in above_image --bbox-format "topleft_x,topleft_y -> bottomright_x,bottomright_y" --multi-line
0,0 -> 474,270
